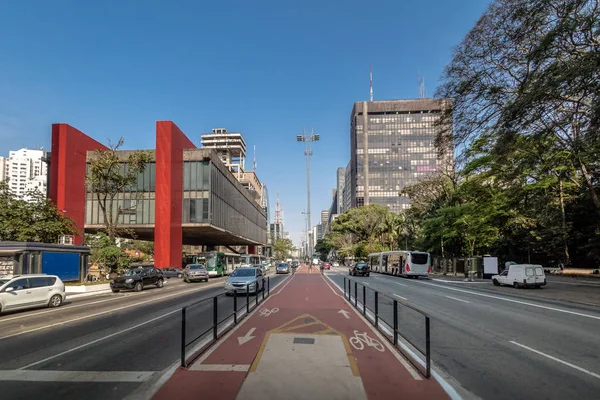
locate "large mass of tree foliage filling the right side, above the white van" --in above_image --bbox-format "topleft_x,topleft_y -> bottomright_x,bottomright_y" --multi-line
402,0 -> 600,266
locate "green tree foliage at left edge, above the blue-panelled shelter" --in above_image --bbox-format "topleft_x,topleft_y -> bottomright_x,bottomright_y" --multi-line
0,182 -> 77,243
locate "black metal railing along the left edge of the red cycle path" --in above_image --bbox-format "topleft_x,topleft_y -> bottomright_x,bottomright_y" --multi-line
181,277 -> 271,368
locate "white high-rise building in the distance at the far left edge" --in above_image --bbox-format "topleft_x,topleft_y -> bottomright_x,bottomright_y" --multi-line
0,149 -> 48,200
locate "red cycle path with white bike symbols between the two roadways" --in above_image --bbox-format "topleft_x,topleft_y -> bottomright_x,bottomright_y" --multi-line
153,267 -> 448,400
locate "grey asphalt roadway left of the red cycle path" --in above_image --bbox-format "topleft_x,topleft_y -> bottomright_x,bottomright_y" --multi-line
0,274 -> 287,400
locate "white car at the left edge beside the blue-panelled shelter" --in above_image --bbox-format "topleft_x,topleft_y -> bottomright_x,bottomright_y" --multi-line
0,274 -> 67,313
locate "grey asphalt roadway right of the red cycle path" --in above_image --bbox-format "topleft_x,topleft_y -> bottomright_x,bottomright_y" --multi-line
326,268 -> 600,400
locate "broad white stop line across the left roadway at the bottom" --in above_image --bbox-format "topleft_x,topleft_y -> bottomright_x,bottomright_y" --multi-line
0,369 -> 155,382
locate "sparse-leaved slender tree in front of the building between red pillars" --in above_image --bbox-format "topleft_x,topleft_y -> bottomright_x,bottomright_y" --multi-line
86,138 -> 152,243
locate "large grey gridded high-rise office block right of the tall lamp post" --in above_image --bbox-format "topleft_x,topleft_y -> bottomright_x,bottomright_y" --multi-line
346,99 -> 451,213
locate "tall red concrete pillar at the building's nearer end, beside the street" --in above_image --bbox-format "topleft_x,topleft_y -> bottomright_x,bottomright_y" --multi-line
154,121 -> 196,268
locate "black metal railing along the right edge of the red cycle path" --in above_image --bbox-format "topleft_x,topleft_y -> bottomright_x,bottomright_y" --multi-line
344,277 -> 431,378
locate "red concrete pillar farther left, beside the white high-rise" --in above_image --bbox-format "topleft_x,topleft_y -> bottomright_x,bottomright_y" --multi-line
49,124 -> 107,244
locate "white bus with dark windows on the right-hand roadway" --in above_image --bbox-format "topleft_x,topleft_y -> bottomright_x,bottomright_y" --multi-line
369,250 -> 431,278
